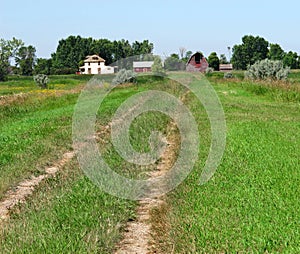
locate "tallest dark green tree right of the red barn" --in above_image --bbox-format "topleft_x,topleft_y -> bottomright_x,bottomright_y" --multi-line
231,35 -> 269,70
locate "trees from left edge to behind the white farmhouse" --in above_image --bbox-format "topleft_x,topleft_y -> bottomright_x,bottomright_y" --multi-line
0,36 -> 154,81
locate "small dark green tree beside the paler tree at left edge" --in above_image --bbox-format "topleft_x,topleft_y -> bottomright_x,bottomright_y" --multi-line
15,45 -> 36,76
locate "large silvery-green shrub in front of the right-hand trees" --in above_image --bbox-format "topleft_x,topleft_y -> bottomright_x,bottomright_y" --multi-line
245,59 -> 290,80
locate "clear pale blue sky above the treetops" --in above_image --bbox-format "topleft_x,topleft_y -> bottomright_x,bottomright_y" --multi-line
0,0 -> 300,57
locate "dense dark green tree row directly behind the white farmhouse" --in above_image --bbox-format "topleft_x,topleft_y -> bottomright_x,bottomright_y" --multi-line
49,36 -> 153,74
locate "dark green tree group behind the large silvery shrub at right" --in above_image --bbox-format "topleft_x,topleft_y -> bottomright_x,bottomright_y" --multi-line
231,35 -> 300,70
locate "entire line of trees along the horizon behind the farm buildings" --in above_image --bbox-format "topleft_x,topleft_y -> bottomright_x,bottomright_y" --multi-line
0,35 -> 300,81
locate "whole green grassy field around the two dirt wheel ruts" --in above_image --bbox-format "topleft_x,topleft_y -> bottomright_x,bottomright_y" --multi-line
0,72 -> 300,253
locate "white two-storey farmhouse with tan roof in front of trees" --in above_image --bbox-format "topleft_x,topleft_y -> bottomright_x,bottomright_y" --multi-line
80,55 -> 115,74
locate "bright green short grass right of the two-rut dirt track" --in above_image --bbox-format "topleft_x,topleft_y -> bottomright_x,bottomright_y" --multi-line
153,73 -> 300,253
